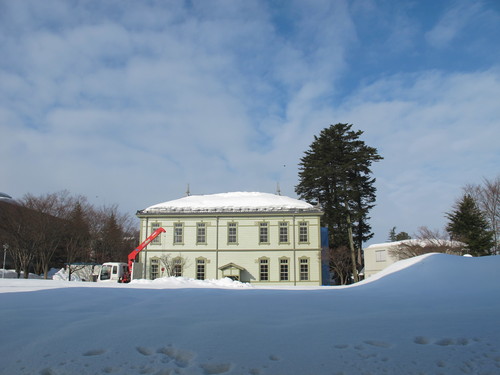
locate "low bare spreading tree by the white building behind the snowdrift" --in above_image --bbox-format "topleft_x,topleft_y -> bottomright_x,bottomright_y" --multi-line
389,227 -> 466,260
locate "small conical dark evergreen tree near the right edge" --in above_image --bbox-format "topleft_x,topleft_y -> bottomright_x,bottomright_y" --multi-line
446,194 -> 494,256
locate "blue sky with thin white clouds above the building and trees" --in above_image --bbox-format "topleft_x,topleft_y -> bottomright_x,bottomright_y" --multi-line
0,0 -> 500,243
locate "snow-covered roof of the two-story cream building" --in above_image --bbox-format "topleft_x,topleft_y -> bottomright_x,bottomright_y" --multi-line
138,192 -> 320,214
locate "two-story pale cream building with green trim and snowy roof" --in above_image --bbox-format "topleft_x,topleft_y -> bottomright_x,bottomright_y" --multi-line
133,192 -> 322,285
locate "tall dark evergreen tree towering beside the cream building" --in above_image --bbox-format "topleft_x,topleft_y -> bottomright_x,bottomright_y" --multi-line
295,124 -> 382,280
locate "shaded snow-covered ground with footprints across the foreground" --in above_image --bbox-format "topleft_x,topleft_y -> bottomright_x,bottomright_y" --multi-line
0,254 -> 500,375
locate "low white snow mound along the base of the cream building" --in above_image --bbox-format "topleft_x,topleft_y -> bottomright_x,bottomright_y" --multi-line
130,276 -> 253,289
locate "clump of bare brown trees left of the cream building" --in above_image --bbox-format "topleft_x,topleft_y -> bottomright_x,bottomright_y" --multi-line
0,191 -> 138,278
